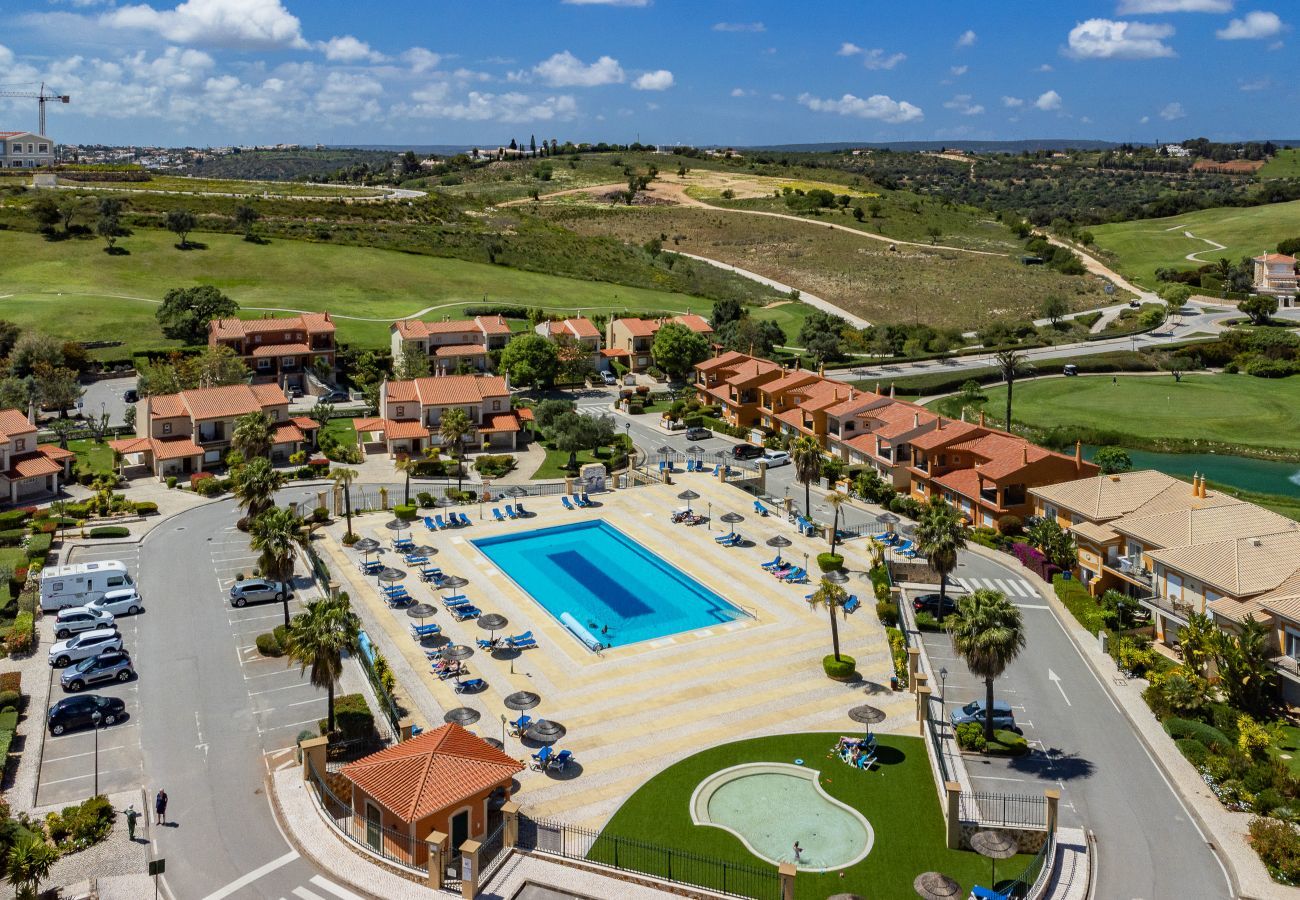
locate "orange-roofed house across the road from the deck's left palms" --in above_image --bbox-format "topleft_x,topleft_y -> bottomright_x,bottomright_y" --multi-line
109,384 -> 320,479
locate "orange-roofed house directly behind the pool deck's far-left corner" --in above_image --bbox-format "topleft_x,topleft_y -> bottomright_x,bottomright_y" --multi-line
354,375 -> 523,457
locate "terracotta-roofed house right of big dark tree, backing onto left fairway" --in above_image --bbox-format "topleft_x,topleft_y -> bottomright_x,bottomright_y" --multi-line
208,312 -> 335,391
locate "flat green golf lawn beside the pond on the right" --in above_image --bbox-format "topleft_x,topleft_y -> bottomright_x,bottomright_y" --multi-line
984,375 -> 1300,450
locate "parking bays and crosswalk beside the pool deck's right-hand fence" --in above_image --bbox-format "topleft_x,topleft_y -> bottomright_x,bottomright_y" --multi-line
922,577 -> 1082,826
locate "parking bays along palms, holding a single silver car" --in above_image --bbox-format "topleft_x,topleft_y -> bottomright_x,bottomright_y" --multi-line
208,525 -> 326,765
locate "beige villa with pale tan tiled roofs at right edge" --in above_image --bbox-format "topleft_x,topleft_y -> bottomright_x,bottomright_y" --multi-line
1031,470 -> 1300,702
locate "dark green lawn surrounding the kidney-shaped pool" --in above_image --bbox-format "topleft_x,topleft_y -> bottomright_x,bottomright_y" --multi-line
597,734 -> 1030,900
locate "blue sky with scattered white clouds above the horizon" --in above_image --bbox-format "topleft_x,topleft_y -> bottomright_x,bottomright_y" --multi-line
0,0 -> 1300,146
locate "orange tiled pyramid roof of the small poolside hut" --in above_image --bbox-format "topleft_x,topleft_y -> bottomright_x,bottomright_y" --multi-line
342,724 -> 524,822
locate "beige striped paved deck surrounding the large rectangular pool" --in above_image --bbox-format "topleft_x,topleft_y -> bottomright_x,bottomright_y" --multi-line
324,475 -> 915,827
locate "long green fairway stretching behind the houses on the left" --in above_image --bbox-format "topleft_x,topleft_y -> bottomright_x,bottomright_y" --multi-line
0,229 -> 733,359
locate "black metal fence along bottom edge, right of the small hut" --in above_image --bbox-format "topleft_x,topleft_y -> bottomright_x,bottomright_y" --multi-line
519,815 -> 781,900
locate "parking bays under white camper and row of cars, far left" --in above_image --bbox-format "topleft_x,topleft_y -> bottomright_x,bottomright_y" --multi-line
36,544 -> 150,806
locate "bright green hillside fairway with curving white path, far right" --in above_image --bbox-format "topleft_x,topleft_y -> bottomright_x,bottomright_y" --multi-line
1089,200 -> 1300,287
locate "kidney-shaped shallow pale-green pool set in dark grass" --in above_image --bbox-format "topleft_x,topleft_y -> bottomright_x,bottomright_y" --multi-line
690,762 -> 875,871
